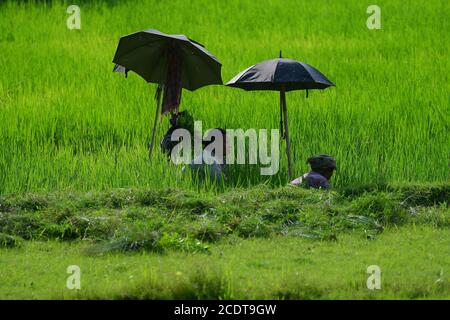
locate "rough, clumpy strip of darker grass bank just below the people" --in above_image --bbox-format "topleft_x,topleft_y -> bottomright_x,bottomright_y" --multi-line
0,185 -> 450,253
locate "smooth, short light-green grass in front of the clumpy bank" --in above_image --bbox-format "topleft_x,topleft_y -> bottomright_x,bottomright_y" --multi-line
0,226 -> 450,299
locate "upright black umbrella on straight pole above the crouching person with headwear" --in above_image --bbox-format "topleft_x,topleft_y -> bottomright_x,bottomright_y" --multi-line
226,52 -> 334,179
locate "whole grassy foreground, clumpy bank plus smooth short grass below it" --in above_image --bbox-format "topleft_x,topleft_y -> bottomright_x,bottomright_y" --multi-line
0,185 -> 450,299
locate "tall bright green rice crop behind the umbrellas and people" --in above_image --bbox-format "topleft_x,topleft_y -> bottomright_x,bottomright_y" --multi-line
0,0 -> 450,193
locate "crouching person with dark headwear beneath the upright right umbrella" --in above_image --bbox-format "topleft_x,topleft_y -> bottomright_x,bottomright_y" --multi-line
291,154 -> 336,189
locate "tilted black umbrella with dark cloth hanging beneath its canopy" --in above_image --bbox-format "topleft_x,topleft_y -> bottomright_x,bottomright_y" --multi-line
113,30 -> 222,155
